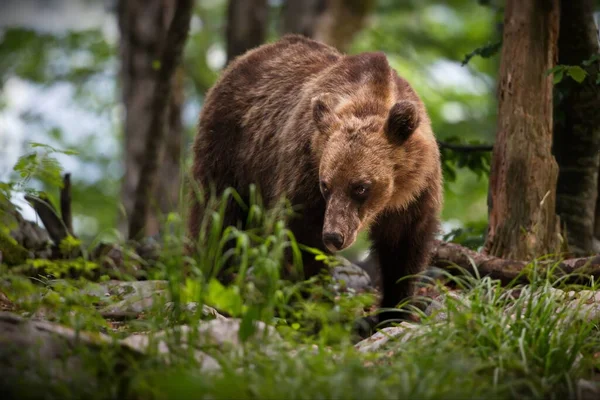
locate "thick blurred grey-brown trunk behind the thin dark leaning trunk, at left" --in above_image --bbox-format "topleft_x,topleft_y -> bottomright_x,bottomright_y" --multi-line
118,0 -> 182,236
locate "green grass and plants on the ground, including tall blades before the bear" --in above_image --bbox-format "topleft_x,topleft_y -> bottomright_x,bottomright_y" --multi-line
2,186 -> 600,400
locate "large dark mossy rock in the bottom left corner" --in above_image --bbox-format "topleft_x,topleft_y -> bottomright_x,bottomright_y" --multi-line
0,312 -> 143,398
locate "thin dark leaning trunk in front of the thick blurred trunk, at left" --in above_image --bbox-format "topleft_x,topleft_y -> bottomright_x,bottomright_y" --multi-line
128,0 -> 194,238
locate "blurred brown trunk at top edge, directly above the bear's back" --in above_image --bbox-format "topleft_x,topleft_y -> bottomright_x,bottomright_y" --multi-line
282,0 -> 377,51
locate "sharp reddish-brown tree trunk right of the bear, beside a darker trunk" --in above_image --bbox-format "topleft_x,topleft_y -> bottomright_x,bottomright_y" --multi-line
485,0 -> 559,260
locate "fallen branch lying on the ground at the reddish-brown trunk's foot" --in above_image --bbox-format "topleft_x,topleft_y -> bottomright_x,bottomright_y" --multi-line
431,242 -> 600,285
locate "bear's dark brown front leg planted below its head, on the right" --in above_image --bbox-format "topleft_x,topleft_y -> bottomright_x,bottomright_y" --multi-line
371,210 -> 437,323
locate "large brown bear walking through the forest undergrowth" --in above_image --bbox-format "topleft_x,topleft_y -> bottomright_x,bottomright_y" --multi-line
189,35 -> 442,328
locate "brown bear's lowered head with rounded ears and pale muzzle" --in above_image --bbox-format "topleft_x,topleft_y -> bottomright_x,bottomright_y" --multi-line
311,93 -> 420,252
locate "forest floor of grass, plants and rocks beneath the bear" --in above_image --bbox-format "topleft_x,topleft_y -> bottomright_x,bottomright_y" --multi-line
0,260 -> 600,400
